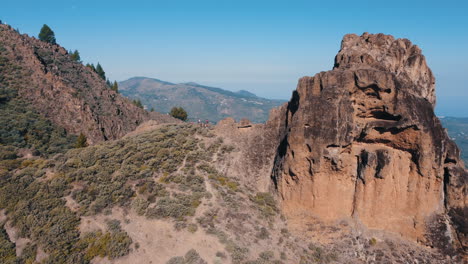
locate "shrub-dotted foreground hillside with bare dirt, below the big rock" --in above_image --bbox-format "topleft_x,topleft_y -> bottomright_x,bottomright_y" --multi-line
0,122 -> 451,264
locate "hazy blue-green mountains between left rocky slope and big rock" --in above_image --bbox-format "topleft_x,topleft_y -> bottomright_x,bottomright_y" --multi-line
119,77 -> 286,123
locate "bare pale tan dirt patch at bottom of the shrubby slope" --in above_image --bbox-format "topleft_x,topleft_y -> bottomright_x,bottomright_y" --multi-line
80,209 -> 224,264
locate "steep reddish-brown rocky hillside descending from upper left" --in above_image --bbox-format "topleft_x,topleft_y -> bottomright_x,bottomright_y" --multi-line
0,25 -> 174,143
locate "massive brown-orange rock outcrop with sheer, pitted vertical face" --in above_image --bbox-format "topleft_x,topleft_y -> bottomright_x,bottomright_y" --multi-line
272,34 -> 468,254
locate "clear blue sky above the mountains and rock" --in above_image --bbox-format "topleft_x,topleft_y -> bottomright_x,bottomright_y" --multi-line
0,0 -> 468,116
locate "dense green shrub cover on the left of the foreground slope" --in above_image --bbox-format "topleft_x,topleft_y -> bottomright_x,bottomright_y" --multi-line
0,125 -> 225,263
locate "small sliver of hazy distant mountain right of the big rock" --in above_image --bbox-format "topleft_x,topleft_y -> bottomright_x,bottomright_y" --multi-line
440,117 -> 468,166
